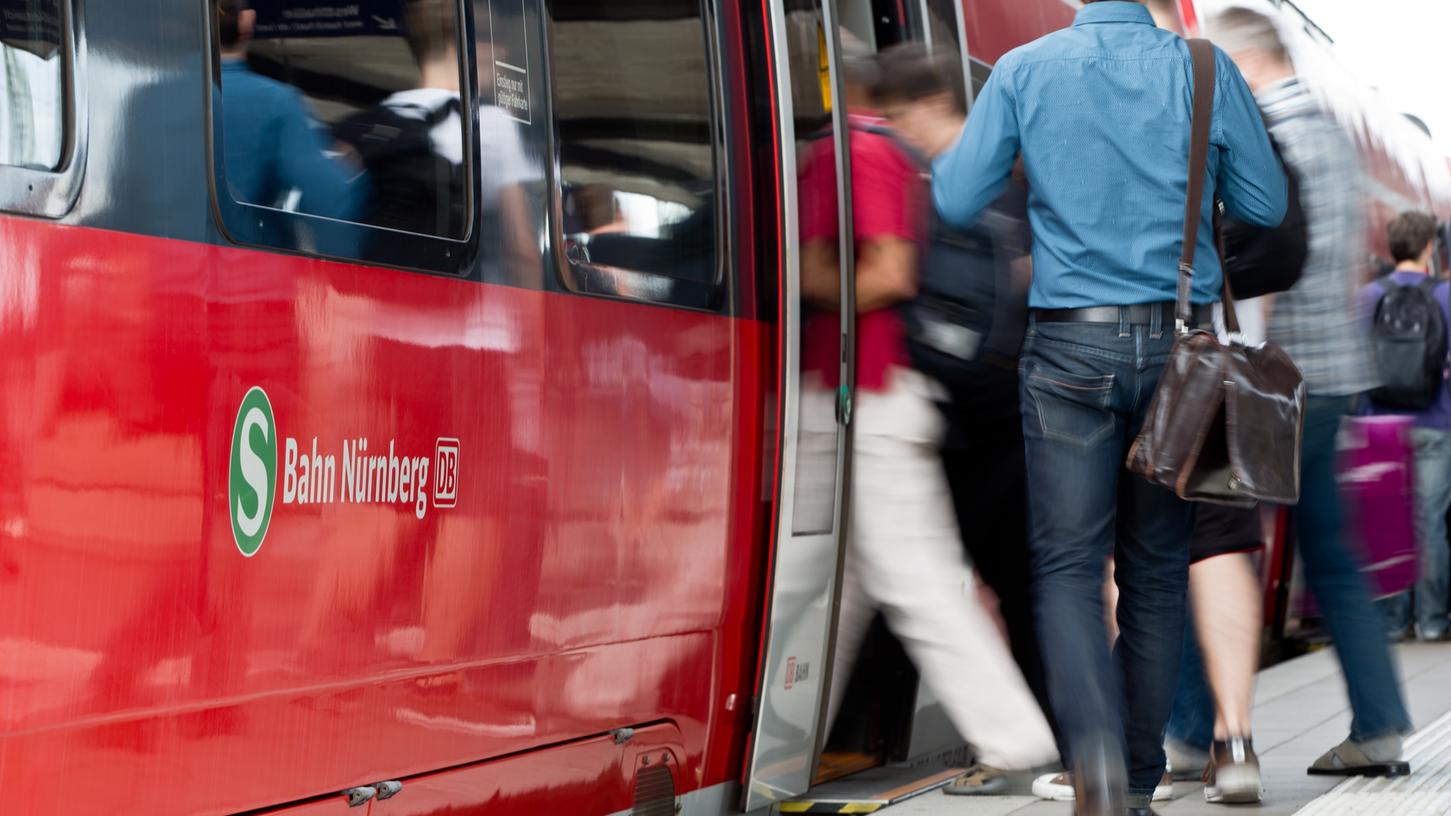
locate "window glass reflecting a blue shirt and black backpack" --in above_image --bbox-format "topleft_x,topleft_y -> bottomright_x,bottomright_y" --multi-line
215,0 -> 470,244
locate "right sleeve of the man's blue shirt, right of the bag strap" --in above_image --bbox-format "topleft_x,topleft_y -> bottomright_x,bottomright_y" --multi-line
1214,48 -> 1288,227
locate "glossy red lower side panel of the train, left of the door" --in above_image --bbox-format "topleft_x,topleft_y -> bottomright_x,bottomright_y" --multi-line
0,218 -> 766,816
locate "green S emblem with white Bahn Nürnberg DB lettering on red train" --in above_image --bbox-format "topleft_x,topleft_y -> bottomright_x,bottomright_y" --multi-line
226,386 -> 459,558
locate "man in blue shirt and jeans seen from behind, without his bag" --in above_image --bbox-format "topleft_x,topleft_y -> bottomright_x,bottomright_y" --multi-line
933,0 -> 1286,816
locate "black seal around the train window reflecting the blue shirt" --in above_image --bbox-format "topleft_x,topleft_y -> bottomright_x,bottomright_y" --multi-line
196,0 -> 479,277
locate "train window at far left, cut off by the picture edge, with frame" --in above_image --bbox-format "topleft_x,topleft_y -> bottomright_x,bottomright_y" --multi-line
0,0 -> 86,218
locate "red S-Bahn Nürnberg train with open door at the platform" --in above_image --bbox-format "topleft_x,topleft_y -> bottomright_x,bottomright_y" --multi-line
0,0 -> 1444,816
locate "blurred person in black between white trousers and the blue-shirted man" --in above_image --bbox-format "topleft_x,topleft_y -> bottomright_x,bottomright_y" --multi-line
878,44 -> 1052,794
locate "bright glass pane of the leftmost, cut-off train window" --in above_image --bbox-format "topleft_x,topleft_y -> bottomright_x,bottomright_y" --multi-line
0,0 -> 65,170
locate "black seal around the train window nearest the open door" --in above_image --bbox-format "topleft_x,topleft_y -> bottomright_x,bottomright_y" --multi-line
538,0 -> 733,312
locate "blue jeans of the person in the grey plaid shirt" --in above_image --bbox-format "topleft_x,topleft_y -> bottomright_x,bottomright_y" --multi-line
1293,395 -> 1410,740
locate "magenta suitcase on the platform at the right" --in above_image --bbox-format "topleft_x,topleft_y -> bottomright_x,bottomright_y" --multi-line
1338,417 -> 1416,598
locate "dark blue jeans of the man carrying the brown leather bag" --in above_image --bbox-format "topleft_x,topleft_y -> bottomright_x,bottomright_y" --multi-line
1022,319 -> 1193,804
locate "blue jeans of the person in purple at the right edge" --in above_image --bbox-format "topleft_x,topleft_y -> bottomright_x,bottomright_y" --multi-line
1381,428 -> 1451,637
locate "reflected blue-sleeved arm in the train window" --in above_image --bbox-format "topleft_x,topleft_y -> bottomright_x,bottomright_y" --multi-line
277,94 -> 361,218
